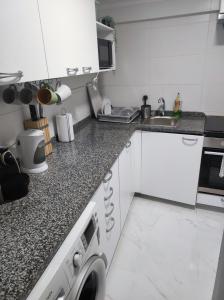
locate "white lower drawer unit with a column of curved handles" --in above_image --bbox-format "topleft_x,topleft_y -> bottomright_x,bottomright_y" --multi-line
92,161 -> 121,270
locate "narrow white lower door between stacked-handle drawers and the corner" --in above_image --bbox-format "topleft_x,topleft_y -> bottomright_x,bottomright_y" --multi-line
119,141 -> 134,228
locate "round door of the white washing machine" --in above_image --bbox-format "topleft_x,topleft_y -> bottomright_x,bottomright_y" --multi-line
68,255 -> 107,300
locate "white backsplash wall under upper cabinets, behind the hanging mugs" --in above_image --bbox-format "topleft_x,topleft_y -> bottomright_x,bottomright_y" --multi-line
0,75 -> 94,146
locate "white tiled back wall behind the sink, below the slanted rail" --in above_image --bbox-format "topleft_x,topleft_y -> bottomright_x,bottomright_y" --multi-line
101,1 -> 224,115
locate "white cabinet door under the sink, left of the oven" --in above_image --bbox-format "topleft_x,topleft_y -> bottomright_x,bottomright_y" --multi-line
141,132 -> 203,205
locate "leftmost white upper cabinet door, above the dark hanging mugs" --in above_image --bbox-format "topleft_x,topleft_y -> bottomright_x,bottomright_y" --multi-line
0,0 -> 48,84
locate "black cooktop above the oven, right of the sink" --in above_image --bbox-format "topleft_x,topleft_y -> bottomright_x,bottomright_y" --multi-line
205,116 -> 224,137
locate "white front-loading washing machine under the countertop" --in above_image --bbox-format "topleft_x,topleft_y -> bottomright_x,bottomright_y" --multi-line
27,202 -> 107,300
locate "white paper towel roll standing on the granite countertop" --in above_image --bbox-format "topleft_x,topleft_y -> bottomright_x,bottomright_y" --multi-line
56,113 -> 74,142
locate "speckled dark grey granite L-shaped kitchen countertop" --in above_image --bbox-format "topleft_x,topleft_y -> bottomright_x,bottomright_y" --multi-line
0,115 -> 204,300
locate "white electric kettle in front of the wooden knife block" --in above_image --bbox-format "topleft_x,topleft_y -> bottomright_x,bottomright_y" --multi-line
16,129 -> 48,174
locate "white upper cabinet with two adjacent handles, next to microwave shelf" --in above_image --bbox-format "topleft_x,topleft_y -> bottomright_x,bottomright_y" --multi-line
38,0 -> 99,78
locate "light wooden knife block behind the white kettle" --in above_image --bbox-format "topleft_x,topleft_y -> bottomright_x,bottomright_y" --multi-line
23,118 -> 53,156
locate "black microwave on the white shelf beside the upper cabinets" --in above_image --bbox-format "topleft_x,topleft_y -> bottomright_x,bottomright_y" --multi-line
98,39 -> 113,69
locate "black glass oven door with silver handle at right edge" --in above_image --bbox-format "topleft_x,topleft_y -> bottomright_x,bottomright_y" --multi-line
198,148 -> 224,195
